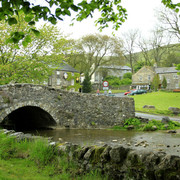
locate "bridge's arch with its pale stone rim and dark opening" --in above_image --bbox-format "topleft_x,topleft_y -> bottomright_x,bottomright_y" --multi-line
0,101 -> 58,131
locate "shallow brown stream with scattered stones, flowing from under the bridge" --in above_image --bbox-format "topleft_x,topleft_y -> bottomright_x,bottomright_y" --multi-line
25,129 -> 180,156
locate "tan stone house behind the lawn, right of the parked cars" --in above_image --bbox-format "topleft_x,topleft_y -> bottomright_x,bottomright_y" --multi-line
131,66 -> 180,90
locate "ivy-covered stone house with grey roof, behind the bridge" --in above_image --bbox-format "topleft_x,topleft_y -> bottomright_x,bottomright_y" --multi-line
48,62 -> 81,91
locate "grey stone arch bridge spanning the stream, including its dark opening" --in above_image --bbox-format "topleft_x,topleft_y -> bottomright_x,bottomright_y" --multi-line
0,84 -> 135,130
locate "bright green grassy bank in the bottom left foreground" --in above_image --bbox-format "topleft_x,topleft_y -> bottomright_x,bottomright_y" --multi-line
0,132 -> 105,180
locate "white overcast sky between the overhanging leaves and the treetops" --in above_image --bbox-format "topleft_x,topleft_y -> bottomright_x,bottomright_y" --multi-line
55,0 -> 163,39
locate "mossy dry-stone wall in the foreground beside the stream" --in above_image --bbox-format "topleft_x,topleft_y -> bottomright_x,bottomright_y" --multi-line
59,143 -> 180,180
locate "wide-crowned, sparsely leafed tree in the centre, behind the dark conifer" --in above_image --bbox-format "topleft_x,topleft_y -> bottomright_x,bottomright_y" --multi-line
68,34 -> 122,77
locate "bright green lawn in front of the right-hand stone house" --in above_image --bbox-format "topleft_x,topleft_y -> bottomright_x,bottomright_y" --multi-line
131,91 -> 180,114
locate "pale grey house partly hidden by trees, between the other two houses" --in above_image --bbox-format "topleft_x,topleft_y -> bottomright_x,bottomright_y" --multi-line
91,65 -> 131,84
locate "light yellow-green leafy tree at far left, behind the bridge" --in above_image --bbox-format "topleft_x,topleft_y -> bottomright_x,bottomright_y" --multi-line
0,14 -> 68,84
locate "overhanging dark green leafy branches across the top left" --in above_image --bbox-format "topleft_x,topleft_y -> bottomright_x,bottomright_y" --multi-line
0,0 -> 127,44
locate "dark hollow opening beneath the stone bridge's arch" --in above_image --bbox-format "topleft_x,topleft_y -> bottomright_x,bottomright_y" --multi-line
0,106 -> 56,131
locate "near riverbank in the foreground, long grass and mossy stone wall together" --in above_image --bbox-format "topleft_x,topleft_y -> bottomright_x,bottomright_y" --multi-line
0,130 -> 180,180
